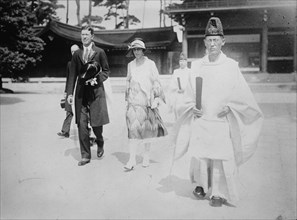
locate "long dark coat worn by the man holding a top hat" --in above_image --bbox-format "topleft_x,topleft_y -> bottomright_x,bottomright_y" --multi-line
67,43 -> 110,127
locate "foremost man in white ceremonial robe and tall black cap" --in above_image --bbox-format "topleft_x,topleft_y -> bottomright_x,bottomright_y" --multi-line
173,17 -> 263,207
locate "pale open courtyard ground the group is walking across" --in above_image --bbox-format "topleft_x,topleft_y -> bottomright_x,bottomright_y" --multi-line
0,84 -> 296,219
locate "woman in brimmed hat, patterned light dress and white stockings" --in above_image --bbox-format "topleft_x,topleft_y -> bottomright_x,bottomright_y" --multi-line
124,39 -> 167,171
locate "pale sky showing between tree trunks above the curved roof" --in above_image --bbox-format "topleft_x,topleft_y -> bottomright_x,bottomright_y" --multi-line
57,0 -> 181,30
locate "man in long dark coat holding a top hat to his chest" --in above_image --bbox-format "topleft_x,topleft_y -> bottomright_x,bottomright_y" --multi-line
67,26 -> 110,166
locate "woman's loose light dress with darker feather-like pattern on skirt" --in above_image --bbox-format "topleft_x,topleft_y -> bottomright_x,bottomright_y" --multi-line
125,57 -> 167,139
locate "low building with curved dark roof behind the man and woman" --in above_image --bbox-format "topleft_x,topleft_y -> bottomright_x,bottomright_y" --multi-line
30,21 -> 181,77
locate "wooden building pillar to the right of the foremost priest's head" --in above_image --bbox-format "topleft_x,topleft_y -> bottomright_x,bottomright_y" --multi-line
260,10 -> 268,73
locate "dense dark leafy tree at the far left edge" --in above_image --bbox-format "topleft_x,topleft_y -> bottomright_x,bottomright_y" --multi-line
0,0 -> 44,85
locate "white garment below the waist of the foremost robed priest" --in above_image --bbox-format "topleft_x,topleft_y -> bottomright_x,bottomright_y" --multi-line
189,119 -> 238,202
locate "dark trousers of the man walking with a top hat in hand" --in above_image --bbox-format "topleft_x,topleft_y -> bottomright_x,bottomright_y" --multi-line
78,105 -> 104,159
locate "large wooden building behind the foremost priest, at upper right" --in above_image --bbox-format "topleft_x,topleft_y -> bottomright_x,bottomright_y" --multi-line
165,0 -> 297,73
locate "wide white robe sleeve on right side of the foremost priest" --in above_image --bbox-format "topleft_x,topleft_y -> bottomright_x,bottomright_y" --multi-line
227,67 -> 263,165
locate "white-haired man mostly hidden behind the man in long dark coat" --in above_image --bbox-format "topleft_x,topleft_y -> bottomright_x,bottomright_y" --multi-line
58,44 -> 79,138
